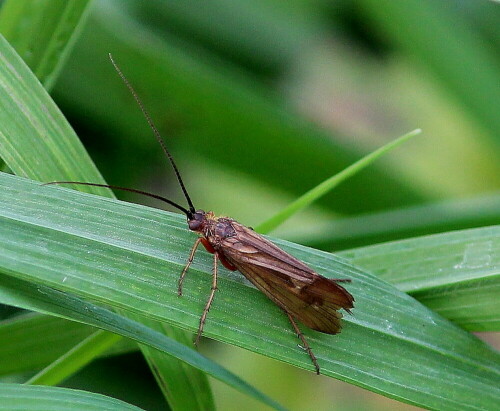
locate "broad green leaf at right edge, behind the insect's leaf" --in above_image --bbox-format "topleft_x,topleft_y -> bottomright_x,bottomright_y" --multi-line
339,226 -> 500,331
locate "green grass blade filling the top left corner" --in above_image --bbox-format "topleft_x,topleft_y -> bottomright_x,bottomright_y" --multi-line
0,0 -> 89,90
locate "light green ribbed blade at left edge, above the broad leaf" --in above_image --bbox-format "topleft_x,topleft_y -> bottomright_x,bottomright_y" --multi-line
0,32 -> 110,195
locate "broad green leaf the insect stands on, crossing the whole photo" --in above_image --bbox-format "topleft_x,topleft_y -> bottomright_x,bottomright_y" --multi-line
0,175 -> 500,409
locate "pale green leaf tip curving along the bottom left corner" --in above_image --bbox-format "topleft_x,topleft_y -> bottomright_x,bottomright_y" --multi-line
0,384 -> 141,411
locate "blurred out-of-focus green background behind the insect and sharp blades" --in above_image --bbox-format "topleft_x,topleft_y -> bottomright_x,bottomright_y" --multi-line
1,0 -> 500,411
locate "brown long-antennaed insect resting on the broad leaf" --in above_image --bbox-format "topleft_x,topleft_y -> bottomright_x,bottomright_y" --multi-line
48,55 -> 354,374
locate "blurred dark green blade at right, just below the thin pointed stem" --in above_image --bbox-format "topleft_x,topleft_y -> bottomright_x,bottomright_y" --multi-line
278,193 -> 500,251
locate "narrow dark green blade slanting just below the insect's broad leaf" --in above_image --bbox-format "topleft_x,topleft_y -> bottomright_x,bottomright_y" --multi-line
0,275 -> 283,409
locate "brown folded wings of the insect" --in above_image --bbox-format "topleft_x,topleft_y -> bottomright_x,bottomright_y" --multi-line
219,222 -> 354,334
